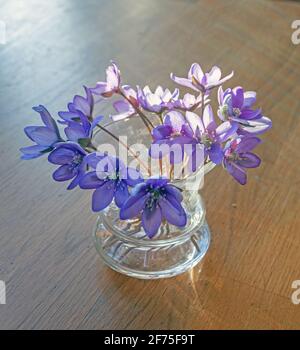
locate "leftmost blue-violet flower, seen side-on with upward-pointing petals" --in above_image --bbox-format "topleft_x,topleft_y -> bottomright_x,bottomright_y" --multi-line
20,105 -> 63,160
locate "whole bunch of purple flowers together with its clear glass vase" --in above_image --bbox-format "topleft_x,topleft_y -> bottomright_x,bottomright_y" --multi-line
21,62 -> 272,278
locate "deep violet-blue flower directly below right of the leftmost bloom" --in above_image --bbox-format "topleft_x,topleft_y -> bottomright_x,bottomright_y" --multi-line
48,142 -> 86,190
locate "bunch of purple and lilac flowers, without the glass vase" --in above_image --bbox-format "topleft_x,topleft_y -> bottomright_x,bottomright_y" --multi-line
21,62 -> 272,238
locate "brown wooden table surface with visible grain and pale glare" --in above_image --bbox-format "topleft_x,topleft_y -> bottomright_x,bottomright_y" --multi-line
0,0 -> 300,329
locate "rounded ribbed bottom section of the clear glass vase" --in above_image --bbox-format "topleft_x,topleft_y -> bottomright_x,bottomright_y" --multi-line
94,217 -> 210,279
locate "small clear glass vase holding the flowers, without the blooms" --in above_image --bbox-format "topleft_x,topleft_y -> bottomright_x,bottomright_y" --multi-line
93,118 -> 214,279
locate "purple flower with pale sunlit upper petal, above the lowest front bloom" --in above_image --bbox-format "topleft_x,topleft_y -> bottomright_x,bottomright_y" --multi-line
150,111 -> 197,164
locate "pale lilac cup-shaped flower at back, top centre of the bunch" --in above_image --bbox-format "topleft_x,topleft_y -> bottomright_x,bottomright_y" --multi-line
137,86 -> 179,113
